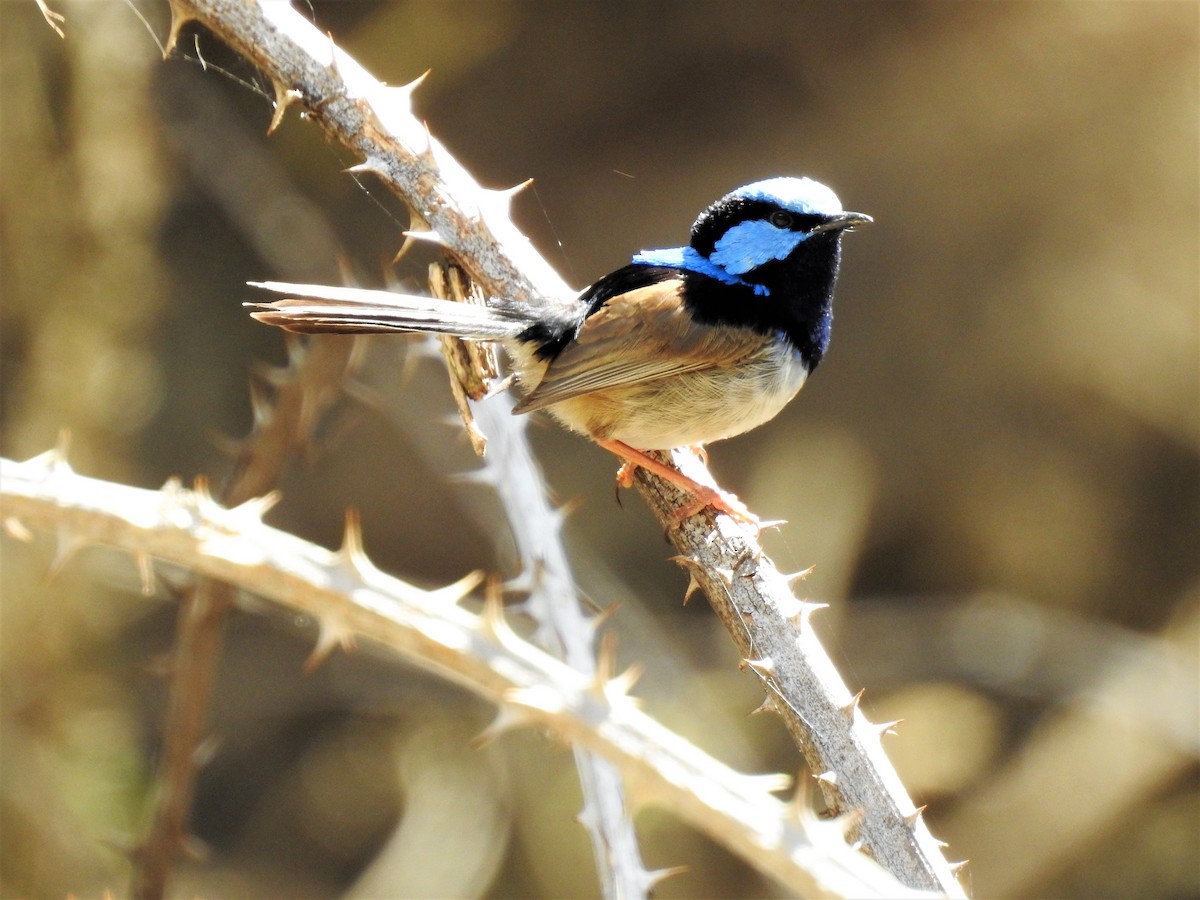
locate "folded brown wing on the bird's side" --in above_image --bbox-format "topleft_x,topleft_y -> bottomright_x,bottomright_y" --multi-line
515,278 -> 763,413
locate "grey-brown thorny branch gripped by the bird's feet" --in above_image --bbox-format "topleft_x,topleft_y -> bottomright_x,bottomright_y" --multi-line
25,0 -> 961,895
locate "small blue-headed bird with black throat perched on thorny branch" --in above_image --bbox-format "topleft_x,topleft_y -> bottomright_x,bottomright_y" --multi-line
247,178 -> 871,523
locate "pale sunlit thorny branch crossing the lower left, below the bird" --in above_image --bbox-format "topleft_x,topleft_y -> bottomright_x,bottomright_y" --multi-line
0,451 -> 919,898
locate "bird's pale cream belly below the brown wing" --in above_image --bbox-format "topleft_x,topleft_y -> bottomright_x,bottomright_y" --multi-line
548,344 -> 808,450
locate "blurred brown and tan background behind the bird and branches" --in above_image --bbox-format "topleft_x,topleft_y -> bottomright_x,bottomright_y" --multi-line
0,0 -> 1200,896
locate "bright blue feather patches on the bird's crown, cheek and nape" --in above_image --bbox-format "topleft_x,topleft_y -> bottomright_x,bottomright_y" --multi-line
632,178 -> 844,296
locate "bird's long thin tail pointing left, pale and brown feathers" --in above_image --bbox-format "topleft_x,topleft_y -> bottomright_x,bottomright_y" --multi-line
246,281 -> 535,341
